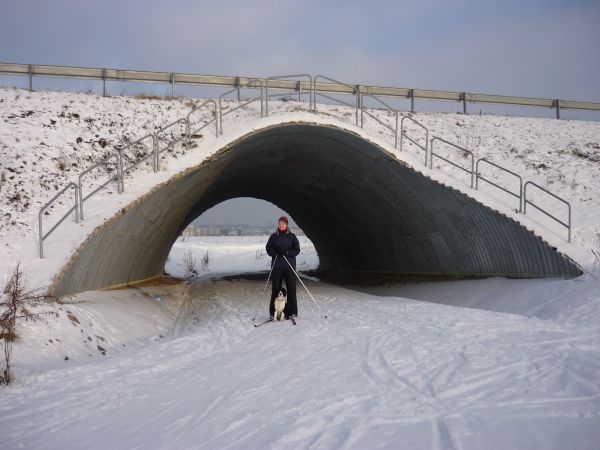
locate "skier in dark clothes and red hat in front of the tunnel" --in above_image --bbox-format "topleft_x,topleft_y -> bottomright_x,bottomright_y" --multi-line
267,216 -> 300,318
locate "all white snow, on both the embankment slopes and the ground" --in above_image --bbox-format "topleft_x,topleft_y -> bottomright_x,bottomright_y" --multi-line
0,89 -> 600,450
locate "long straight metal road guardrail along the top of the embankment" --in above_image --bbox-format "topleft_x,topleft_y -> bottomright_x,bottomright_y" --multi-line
0,62 -> 600,118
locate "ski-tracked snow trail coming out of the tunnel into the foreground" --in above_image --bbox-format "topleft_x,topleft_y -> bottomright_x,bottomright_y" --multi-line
0,279 -> 600,449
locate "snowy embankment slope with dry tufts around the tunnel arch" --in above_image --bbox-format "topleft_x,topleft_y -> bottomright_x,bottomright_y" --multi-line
0,89 -> 600,287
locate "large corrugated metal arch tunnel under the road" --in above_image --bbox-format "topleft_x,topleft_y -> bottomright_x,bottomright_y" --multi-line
50,123 -> 581,296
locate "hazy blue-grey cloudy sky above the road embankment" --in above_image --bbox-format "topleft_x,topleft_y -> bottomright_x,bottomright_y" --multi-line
0,0 -> 600,225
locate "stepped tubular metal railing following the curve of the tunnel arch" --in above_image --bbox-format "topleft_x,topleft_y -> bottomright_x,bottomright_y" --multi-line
34,71 -> 571,258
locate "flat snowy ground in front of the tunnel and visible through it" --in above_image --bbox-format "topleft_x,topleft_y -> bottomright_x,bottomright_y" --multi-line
0,236 -> 600,450
